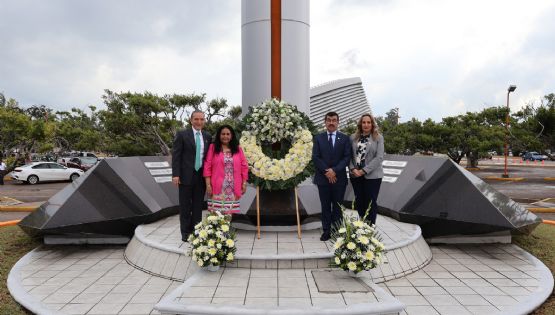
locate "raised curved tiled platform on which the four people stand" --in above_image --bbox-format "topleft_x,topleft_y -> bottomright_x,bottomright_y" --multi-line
125,216 -> 432,283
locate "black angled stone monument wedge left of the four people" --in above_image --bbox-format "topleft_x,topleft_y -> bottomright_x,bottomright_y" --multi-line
19,156 -> 179,237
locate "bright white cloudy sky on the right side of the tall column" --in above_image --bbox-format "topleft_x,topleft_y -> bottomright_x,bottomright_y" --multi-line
311,0 -> 555,120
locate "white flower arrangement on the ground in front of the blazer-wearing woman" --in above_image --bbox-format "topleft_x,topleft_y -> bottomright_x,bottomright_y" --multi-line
332,206 -> 385,274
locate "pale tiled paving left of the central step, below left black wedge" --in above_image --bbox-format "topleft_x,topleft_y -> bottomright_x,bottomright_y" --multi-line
10,247 -> 180,314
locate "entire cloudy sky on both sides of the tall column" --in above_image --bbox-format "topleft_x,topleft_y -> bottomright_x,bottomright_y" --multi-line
0,0 -> 555,121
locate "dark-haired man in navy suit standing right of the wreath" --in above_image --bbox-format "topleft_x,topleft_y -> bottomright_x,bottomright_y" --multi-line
312,112 -> 351,241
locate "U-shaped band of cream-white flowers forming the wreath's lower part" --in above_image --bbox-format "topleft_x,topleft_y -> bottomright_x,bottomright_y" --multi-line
241,128 -> 312,180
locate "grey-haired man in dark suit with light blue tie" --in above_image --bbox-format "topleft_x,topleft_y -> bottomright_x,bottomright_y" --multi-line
172,110 -> 212,242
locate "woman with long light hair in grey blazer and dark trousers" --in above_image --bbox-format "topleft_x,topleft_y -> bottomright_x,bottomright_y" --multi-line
349,114 -> 384,224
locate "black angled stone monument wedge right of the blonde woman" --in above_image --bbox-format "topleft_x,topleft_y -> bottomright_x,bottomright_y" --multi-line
347,155 -> 541,237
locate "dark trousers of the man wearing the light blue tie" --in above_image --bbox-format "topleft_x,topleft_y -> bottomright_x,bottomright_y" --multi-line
179,168 -> 206,239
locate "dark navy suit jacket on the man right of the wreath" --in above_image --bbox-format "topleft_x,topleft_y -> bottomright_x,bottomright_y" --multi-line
312,131 -> 351,185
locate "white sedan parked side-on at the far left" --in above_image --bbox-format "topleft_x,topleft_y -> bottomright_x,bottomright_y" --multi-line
12,162 -> 84,185
